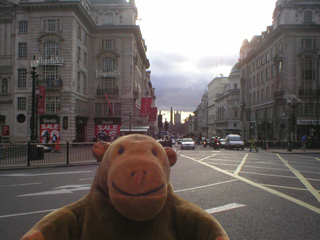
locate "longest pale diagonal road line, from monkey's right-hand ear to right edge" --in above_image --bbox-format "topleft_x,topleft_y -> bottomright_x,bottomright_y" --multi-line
181,155 -> 320,214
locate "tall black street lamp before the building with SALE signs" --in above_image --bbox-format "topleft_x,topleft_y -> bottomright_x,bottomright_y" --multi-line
30,55 -> 39,142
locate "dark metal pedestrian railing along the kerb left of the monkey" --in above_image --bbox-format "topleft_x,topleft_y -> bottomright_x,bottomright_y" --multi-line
0,141 -> 97,169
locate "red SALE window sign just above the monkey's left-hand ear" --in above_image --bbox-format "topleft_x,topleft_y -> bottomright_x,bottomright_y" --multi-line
94,124 -> 121,142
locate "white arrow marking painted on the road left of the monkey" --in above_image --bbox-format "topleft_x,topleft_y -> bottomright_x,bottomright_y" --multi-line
18,184 -> 91,197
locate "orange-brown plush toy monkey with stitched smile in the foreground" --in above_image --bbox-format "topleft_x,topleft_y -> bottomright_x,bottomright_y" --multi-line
22,135 -> 229,240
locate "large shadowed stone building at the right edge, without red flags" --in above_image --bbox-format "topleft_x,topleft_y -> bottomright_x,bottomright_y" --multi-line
238,0 -> 320,142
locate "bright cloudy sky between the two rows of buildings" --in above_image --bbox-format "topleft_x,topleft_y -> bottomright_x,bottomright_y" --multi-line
136,0 -> 276,118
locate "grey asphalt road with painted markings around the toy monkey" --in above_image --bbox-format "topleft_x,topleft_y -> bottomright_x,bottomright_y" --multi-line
0,146 -> 320,240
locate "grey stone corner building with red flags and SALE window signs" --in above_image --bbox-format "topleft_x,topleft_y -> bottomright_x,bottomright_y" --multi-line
0,0 -> 155,142
